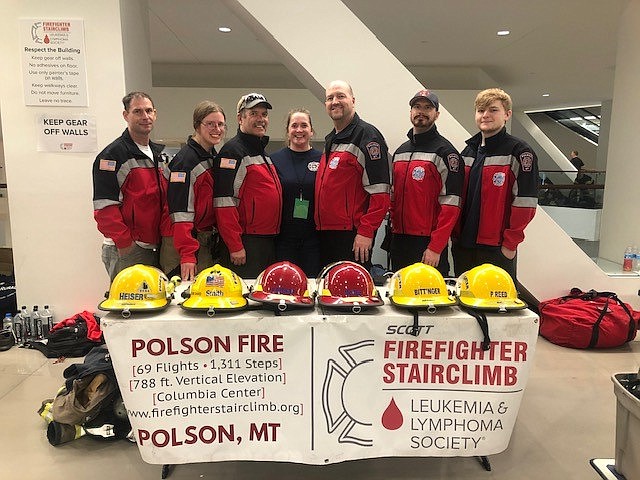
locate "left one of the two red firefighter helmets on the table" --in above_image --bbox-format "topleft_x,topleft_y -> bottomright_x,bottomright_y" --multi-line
249,261 -> 315,311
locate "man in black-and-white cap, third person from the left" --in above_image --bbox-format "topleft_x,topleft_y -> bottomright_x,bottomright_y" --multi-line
213,93 -> 282,278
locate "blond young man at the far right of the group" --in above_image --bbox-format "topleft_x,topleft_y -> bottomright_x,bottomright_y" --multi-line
452,88 -> 538,281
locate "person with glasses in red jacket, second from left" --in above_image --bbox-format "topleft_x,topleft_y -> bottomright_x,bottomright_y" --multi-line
160,100 -> 227,281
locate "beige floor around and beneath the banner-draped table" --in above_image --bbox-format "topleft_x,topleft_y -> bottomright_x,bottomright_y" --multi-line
0,338 -> 640,480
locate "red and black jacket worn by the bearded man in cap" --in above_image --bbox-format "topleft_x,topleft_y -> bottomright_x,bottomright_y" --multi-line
391,125 -> 464,253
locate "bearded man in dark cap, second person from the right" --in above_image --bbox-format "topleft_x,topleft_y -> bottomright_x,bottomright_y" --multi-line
390,89 -> 464,277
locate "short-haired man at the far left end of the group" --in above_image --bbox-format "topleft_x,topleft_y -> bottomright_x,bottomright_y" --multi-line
93,92 -> 166,280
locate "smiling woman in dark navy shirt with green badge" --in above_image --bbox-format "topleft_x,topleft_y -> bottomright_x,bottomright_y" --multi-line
271,108 -> 322,278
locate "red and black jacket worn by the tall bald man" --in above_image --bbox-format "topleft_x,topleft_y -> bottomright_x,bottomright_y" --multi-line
315,114 -> 391,238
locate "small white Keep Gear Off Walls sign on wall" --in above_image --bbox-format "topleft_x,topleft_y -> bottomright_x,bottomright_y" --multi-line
38,114 -> 98,152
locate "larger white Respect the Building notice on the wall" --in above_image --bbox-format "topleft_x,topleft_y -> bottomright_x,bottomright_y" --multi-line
20,18 -> 87,107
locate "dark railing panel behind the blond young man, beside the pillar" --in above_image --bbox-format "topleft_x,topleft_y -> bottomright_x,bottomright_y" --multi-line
538,170 -> 606,209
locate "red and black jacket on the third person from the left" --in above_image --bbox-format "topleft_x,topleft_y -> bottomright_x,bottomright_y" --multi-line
213,129 -> 282,252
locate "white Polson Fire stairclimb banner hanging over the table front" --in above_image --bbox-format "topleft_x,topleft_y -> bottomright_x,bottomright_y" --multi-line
102,309 -> 538,464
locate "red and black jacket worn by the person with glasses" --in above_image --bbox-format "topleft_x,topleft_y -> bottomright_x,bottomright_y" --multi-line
166,137 -> 216,263
